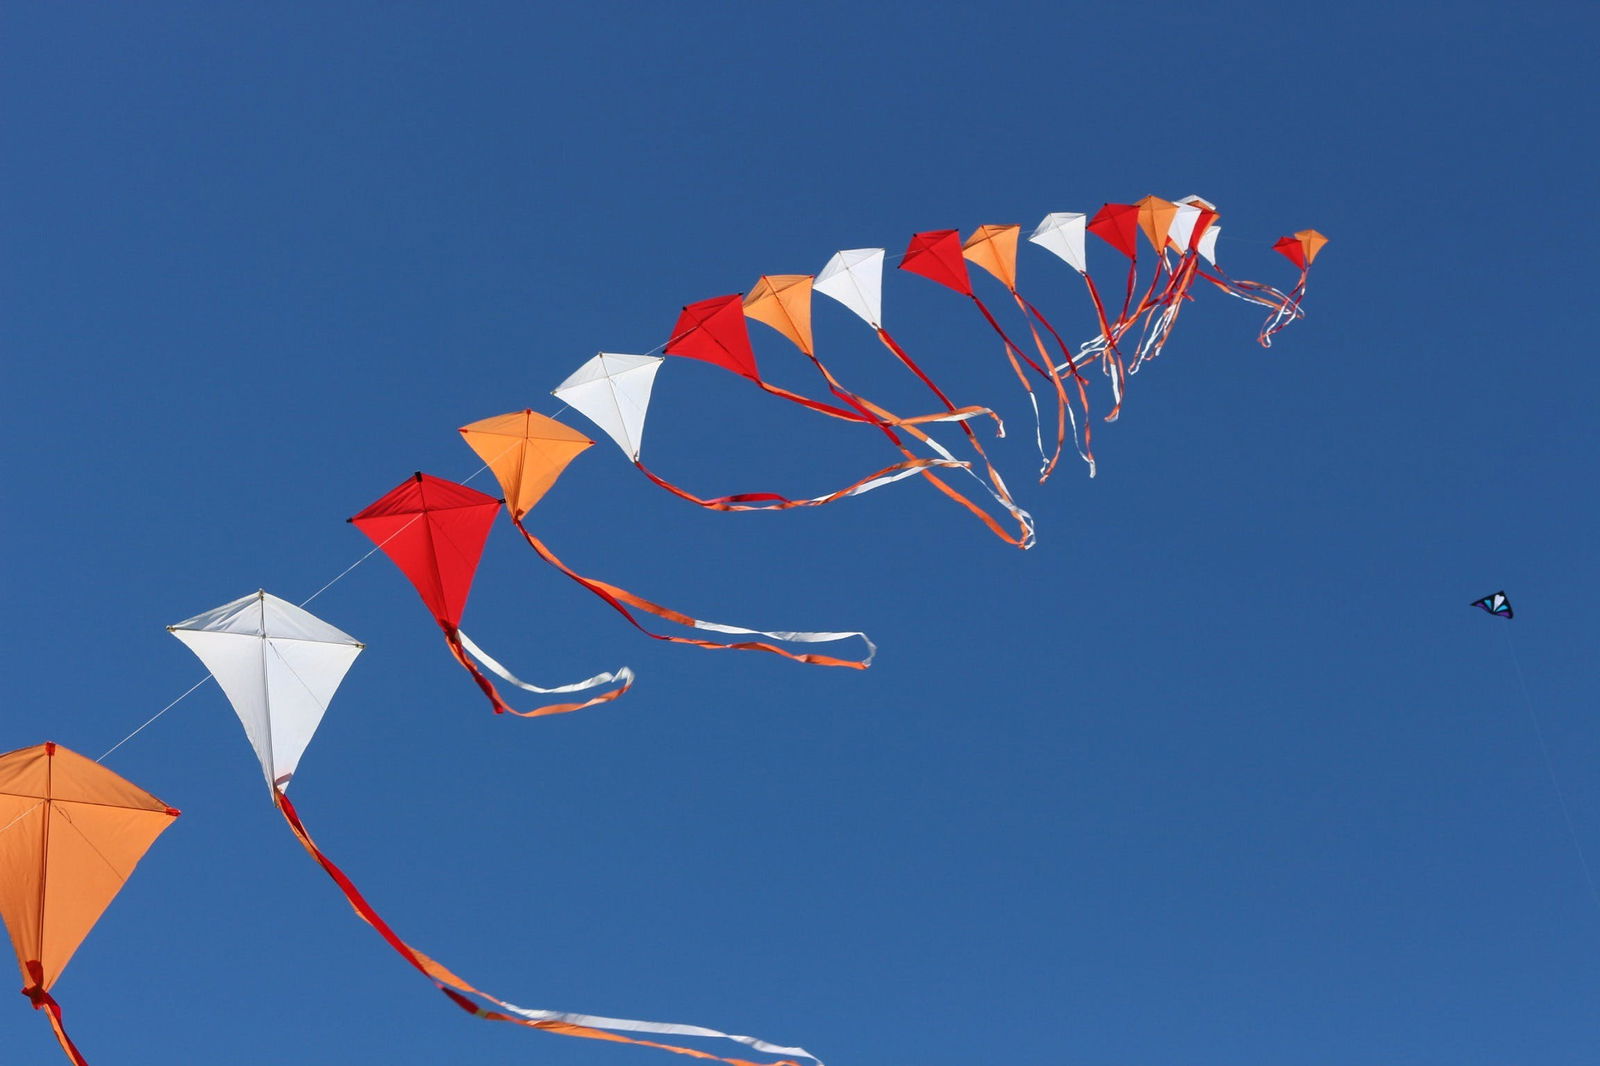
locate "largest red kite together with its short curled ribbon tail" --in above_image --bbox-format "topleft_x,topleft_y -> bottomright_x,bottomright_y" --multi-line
349,470 -> 634,719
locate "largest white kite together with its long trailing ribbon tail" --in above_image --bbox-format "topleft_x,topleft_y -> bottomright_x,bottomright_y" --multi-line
167,589 -> 821,1066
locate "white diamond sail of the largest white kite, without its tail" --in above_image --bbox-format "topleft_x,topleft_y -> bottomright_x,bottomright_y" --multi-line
168,592 -> 363,789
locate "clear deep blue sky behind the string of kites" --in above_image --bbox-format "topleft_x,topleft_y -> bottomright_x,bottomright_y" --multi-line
0,2 -> 1600,1066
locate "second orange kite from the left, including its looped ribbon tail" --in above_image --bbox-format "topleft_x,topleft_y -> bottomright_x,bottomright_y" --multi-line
461,408 -> 877,669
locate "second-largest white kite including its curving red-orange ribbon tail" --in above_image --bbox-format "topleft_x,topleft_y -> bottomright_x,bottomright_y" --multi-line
550,350 -> 981,511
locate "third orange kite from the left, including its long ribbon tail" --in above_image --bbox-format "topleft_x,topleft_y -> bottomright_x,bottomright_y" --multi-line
744,272 -> 1034,549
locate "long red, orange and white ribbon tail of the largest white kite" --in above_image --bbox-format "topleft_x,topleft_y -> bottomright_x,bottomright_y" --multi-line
275,789 -> 821,1066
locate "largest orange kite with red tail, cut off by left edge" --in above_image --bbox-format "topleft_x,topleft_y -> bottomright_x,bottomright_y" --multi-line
0,743 -> 178,1066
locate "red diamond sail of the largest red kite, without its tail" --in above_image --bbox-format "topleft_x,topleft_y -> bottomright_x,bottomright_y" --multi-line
350,474 -> 501,631
